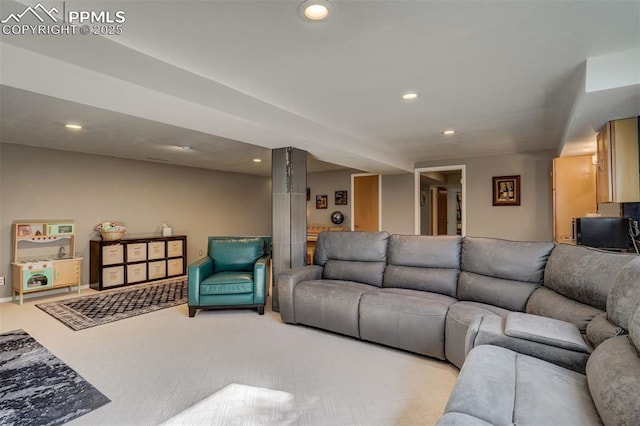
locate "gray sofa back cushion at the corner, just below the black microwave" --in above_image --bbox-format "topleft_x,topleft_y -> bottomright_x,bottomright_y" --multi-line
544,244 -> 635,310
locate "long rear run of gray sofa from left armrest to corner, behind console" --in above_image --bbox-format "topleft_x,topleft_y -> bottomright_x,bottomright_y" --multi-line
276,232 -> 638,368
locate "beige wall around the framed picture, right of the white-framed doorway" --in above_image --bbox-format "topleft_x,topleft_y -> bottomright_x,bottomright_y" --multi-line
415,150 -> 555,241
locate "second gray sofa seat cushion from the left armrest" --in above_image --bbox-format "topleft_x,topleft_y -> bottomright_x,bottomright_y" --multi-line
360,288 -> 456,359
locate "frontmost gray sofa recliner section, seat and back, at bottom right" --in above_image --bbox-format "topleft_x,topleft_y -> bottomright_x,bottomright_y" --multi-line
437,302 -> 640,426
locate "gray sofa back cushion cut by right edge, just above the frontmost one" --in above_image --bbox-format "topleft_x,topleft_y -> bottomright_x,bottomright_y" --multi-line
607,256 -> 640,330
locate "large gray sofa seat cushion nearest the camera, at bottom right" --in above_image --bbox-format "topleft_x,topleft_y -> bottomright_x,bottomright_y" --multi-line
445,345 -> 602,426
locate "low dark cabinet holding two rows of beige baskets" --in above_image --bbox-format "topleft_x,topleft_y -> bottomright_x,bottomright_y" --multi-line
89,235 -> 187,290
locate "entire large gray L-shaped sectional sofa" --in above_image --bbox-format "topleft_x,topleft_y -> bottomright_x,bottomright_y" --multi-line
276,232 -> 640,425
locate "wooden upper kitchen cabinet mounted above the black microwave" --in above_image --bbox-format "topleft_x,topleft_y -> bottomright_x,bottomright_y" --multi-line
596,117 -> 640,203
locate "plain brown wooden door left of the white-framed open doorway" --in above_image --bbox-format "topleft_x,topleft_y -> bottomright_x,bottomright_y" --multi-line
351,173 -> 382,232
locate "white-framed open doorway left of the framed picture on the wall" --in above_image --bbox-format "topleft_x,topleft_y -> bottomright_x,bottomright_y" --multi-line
415,165 -> 466,236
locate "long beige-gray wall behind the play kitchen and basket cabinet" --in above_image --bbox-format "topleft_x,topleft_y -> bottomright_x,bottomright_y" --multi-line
0,143 -> 271,297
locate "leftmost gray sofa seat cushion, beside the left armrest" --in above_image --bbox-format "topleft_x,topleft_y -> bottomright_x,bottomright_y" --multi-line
293,279 -> 376,337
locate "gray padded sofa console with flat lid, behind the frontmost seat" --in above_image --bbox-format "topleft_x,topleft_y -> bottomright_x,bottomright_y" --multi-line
466,313 -> 590,374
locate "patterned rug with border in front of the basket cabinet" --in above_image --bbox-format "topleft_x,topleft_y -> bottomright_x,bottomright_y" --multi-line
36,278 -> 187,331
